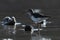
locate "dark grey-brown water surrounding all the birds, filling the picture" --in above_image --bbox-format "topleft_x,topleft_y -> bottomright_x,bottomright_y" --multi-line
0,0 -> 60,40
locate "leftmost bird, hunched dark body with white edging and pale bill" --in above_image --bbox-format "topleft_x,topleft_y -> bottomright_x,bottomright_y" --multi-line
1,16 -> 21,25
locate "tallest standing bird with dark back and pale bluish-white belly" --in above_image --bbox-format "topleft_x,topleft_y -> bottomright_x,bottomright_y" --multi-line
27,9 -> 51,26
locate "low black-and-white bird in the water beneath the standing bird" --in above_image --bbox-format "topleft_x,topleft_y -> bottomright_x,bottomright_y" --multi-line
19,25 -> 43,34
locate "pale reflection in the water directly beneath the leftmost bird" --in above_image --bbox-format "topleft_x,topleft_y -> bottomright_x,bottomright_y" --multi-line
3,25 -> 16,34
